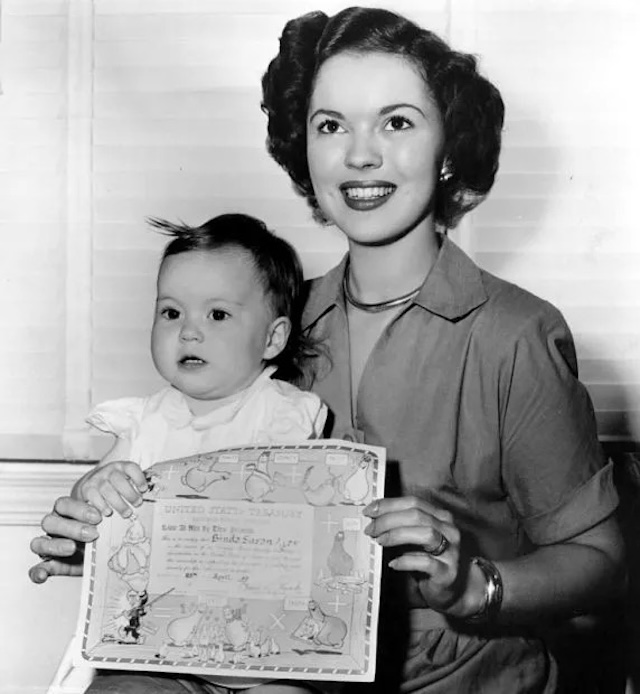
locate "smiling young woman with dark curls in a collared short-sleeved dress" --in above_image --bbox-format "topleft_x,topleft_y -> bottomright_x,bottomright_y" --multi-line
33,8 -> 624,694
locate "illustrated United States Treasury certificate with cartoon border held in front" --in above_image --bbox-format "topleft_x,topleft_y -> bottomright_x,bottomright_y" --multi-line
76,439 -> 385,686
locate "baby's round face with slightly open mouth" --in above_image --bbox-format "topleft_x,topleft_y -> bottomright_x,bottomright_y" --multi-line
151,248 -> 282,414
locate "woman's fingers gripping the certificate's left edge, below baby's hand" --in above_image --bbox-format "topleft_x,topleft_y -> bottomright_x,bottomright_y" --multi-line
29,496 -> 102,583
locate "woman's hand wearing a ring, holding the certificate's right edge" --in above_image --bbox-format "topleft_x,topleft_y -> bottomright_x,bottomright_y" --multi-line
363,497 -> 483,618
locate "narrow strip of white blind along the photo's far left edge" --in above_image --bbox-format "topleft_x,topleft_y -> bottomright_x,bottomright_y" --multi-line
0,0 -> 68,458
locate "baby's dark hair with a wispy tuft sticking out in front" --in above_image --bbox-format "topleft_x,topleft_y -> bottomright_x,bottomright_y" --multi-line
147,213 -> 315,382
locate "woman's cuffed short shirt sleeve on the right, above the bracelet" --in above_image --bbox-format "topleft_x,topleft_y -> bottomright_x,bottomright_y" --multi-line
500,305 -> 618,545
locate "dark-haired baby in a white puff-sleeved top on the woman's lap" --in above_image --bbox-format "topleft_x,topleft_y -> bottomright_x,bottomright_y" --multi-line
72,214 -> 327,694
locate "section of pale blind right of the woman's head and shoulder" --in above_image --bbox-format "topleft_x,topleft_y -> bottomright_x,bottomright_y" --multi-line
469,0 -> 640,441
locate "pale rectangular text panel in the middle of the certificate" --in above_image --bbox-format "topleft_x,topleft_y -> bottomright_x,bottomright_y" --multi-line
153,499 -> 314,599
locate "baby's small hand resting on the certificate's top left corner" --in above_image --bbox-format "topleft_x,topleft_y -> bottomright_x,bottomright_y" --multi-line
71,461 -> 149,518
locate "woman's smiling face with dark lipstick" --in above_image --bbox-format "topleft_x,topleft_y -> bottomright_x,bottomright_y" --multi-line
307,53 -> 444,245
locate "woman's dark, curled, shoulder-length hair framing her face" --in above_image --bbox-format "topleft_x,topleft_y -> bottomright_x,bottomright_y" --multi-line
262,7 -> 504,231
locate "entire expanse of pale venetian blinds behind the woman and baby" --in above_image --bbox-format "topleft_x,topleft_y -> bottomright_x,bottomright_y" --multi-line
0,0 -> 640,458
